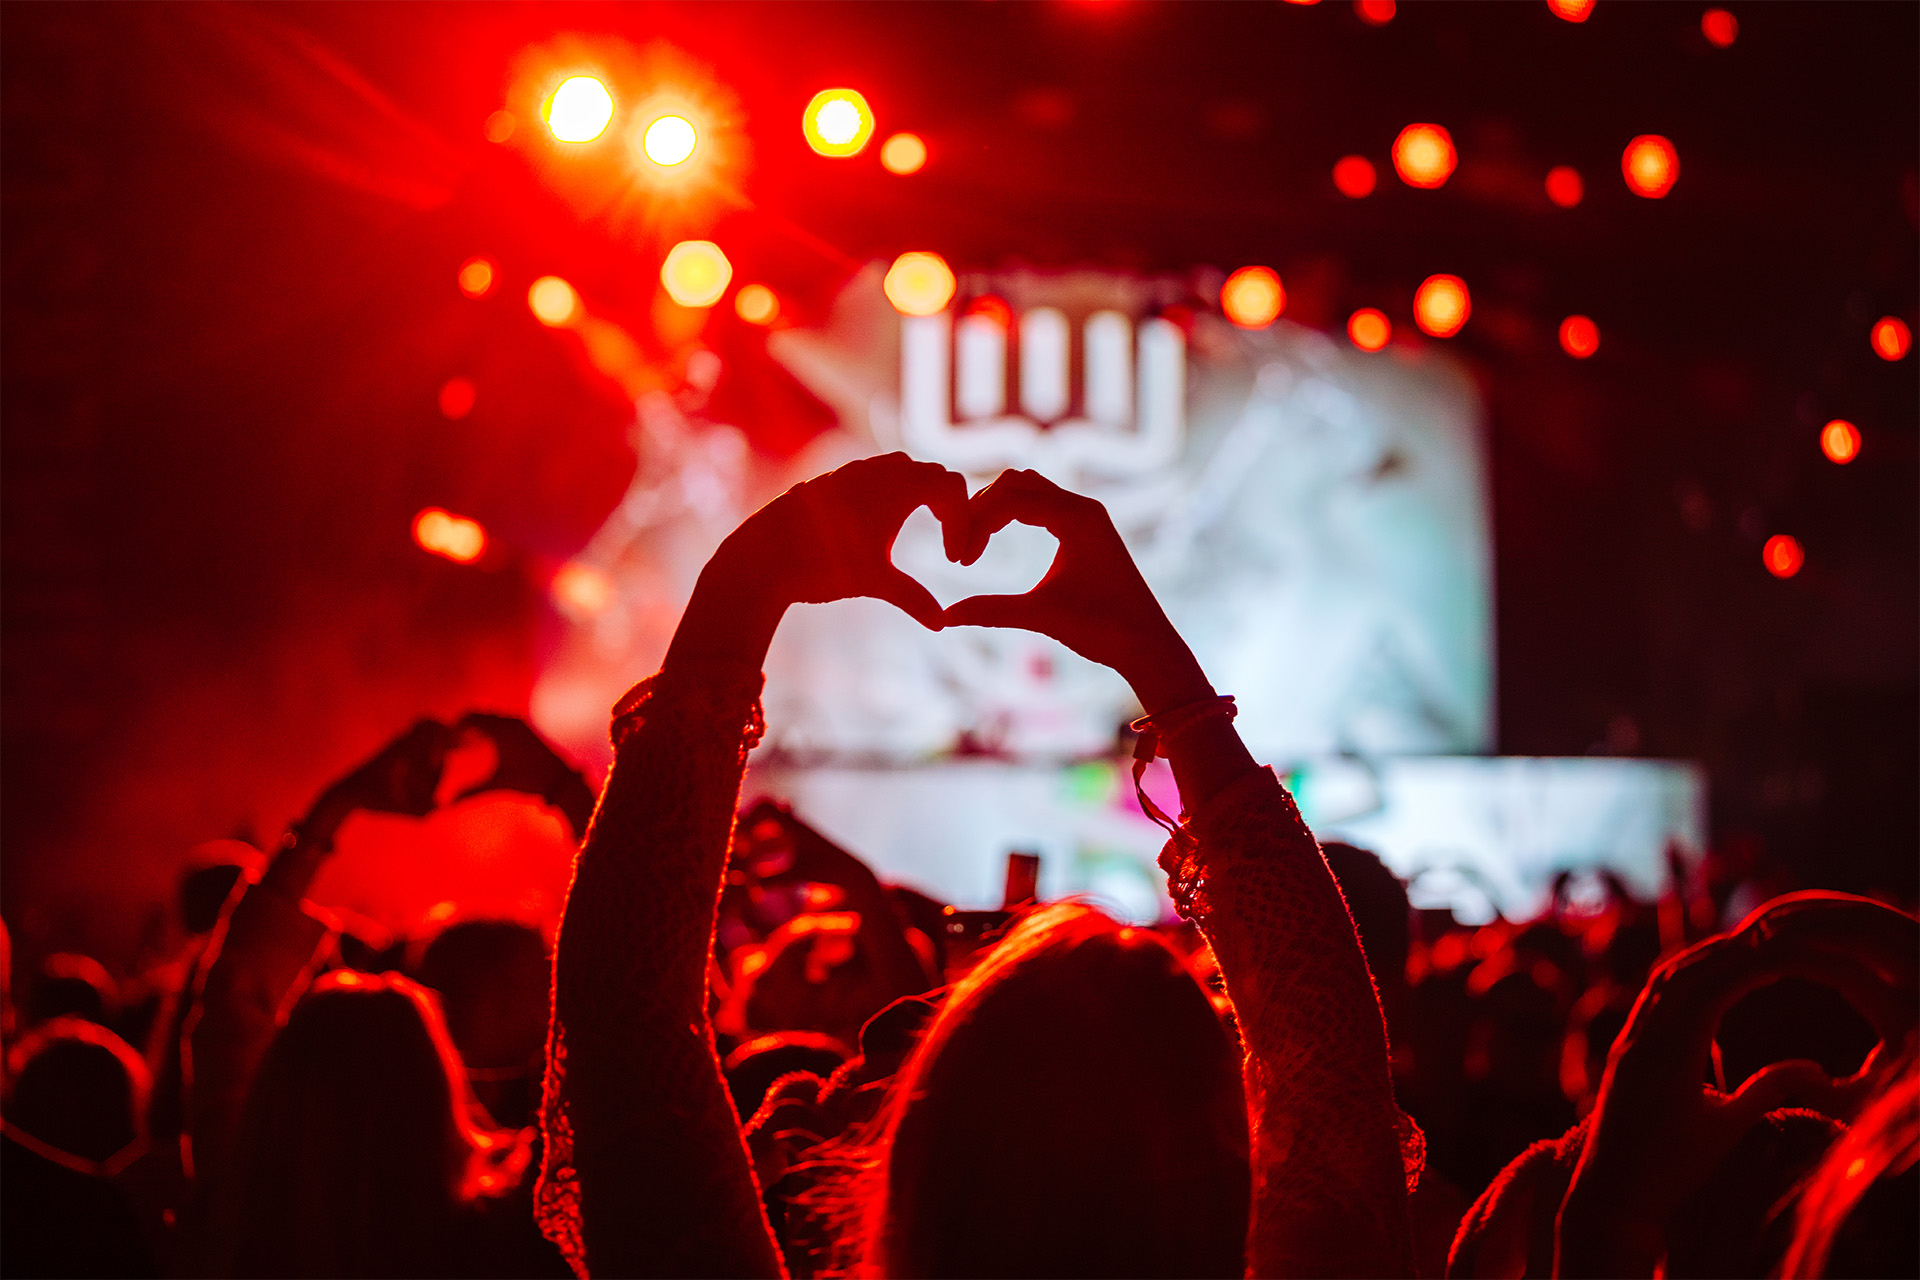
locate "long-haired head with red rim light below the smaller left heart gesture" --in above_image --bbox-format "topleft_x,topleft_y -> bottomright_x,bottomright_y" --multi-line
204,971 -> 506,1276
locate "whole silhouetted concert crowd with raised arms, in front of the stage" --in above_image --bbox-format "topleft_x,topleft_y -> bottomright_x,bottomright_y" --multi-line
0,455 -> 1920,1276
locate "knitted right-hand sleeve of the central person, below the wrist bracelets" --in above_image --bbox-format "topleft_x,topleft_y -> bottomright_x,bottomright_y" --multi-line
1162,770 -> 1413,1276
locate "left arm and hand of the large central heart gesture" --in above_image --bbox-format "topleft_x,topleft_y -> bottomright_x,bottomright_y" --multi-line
538,453 -> 966,1276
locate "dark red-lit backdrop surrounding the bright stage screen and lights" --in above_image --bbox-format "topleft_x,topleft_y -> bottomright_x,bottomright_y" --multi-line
0,0 -> 1920,960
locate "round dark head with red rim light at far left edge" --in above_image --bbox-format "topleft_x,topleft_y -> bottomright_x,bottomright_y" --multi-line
6,1017 -> 154,1167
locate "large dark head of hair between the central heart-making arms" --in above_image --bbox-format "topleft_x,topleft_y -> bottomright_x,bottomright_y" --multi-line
864,904 -> 1250,1276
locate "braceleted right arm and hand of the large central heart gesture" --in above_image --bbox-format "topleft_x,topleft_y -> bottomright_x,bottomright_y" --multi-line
947,472 -> 1413,1276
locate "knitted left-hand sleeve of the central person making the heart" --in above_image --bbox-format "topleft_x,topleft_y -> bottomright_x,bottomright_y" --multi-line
536,672 -> 781,1276
